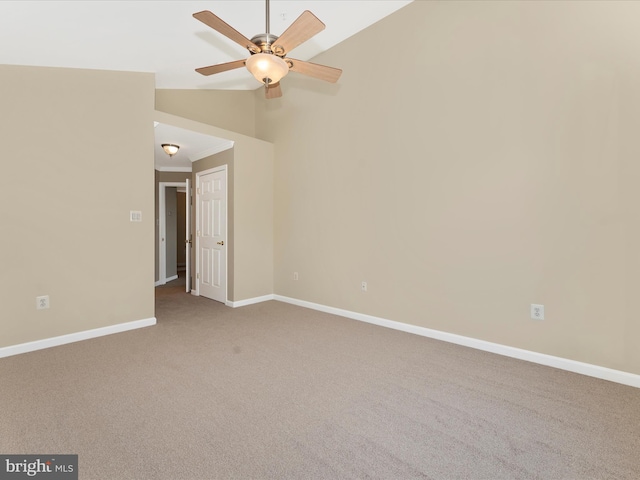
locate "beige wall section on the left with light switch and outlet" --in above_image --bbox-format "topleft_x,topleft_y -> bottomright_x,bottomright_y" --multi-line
0,65 -> 154,347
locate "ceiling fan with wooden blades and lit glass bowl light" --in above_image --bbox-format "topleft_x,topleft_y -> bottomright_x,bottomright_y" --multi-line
193,0 -> 342,98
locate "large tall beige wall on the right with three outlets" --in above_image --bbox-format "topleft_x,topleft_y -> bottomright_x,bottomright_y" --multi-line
255,1 -> 640,374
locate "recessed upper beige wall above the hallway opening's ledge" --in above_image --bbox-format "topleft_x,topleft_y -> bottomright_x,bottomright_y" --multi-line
156,89 -> 255,136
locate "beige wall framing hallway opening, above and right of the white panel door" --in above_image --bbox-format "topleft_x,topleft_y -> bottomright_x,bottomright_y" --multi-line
155,111 -> 274,302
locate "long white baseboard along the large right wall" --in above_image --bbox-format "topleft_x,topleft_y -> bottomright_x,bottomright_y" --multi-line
273,295 -> 640,388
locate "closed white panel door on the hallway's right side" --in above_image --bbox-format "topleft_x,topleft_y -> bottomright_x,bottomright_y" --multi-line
197,169 -> 227,303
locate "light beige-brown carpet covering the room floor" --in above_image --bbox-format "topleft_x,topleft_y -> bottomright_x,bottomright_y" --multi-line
0,284 -> 640,480
